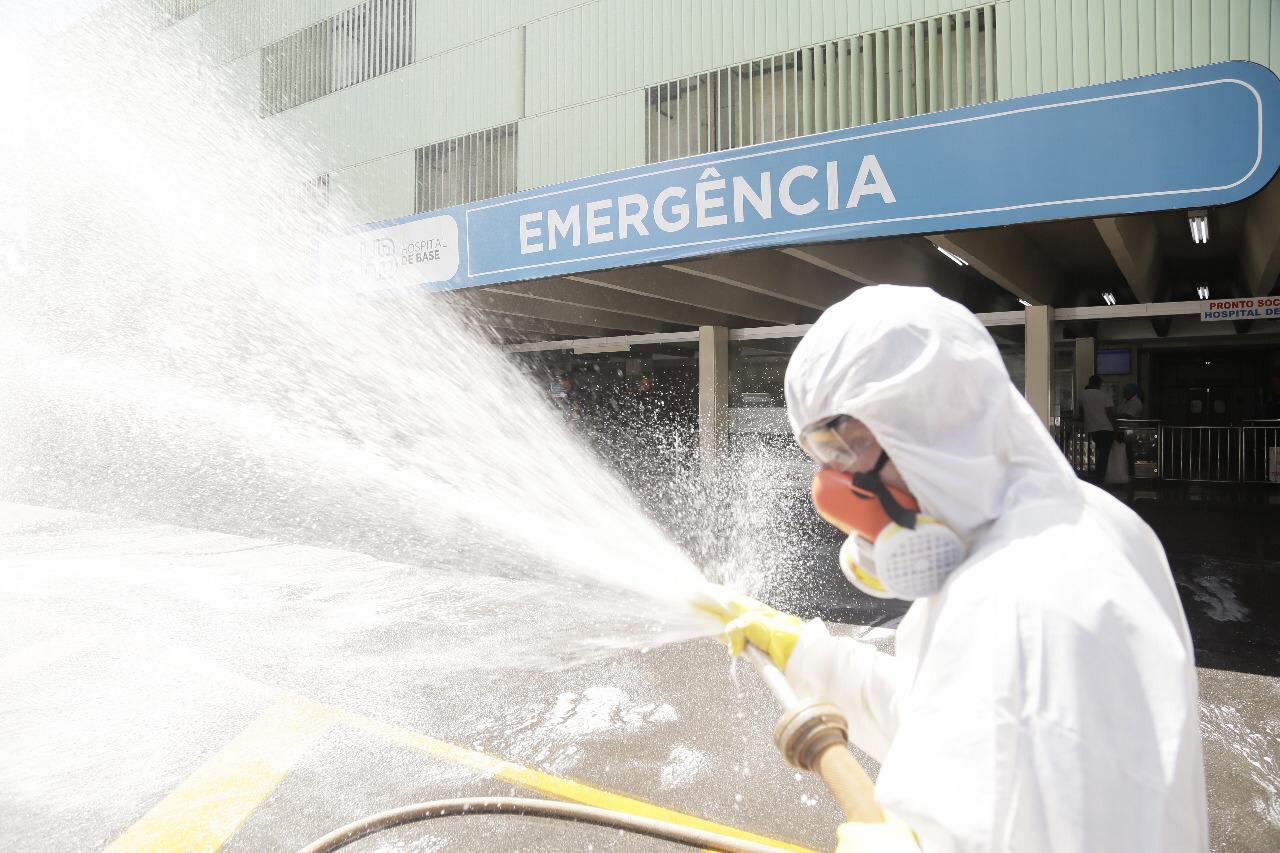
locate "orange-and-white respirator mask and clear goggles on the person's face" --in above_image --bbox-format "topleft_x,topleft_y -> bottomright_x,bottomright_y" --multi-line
800,418 -> 965,601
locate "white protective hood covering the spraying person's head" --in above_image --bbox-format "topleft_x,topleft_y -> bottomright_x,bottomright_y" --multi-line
786,284 -> 1079,538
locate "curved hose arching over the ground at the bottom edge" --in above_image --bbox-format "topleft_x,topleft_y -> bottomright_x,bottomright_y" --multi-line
300,797 -> 783,853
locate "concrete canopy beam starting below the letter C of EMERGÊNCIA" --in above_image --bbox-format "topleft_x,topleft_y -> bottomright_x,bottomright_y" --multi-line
782,238 -> 970,298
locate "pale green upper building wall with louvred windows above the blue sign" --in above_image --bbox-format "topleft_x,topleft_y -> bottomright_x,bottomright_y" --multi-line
155,0 -> 1280,219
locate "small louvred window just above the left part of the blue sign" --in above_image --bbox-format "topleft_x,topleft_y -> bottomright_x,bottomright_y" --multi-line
415,123 -> 518,213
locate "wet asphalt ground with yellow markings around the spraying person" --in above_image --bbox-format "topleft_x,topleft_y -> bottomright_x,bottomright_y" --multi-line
0,505 -> 1280,852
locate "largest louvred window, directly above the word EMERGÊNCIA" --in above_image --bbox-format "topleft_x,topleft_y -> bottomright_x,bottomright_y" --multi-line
645,4 -> 996,163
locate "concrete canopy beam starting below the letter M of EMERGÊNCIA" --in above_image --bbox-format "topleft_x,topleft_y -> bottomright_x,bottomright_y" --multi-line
564,266 -> 818,324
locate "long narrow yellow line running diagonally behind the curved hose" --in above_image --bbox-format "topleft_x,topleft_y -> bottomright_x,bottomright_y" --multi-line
343,712 -> 814,853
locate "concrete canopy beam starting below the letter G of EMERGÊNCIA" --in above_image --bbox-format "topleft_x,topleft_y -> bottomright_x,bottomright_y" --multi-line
666,248 -> 852,311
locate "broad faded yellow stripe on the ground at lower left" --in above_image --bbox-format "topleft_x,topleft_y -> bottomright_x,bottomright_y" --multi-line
106,699 -> 337,853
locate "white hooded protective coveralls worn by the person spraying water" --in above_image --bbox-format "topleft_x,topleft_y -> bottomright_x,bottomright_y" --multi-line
786,286 -> 1208,853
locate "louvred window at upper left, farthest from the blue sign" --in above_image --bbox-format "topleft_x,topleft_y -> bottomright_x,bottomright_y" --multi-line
262,0 -> 416,115
